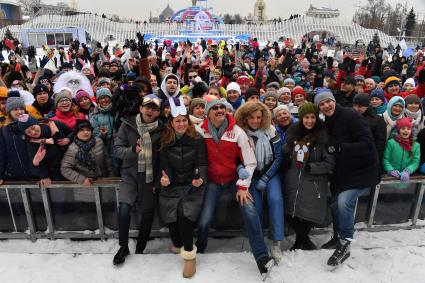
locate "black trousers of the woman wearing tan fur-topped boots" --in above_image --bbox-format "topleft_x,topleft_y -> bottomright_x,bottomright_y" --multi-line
168,202 -> 195,252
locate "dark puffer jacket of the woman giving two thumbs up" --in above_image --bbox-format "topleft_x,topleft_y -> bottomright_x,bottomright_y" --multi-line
159,135 -> 207,223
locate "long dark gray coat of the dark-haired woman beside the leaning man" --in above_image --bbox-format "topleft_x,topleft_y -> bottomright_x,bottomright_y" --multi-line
283,143 -> 335,224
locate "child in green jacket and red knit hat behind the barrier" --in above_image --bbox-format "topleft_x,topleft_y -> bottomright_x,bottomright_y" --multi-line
382,117 -> 421,182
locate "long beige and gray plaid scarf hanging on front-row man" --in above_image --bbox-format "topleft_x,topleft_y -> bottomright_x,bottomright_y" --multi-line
136,114 -> 158,183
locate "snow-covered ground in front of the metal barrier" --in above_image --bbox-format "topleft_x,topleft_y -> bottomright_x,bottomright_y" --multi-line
0,228 -> 425,283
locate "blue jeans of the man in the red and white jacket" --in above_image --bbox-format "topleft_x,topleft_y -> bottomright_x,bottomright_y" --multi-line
196,181 -> 268,260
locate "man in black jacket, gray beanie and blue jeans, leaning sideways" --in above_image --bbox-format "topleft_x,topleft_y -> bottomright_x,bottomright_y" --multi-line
314,91 -> 379,266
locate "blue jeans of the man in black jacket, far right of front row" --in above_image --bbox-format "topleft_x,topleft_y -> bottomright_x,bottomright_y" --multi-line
331,188 -> 370,239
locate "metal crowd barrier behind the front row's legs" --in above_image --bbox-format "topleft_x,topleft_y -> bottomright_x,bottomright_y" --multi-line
0,176 -> 425,241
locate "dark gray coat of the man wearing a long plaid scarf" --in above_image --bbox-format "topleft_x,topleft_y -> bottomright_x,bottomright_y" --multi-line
114,116 -> 164,205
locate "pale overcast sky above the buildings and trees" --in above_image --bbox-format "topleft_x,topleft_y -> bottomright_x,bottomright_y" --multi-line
42,0 -> 425,20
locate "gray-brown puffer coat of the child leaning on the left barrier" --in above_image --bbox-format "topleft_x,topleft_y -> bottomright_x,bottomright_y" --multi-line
61,138 -> 112,184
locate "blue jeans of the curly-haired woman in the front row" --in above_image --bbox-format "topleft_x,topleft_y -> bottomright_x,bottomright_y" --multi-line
249,175 -> 284,241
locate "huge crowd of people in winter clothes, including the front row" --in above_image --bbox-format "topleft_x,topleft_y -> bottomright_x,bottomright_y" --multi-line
0,34 -> 425,278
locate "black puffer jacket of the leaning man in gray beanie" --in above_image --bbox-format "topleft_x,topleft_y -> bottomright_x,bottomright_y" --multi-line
325,104 -> 379,192
